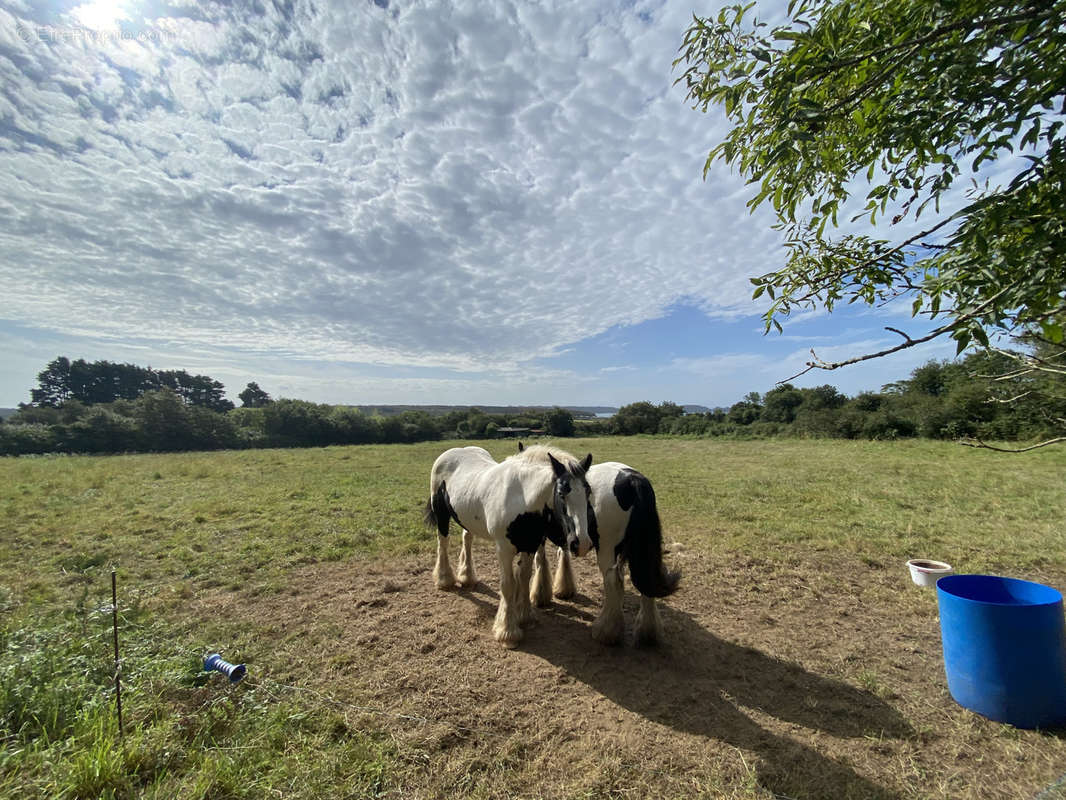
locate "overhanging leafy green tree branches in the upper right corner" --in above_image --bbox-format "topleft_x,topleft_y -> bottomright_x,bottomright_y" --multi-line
675,0 -> 1066,377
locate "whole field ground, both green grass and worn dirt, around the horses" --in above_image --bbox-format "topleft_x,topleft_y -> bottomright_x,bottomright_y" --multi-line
0,437 -> 1066,800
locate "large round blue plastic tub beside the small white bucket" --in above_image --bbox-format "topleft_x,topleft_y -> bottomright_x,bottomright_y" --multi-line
936,575 -> 1066,727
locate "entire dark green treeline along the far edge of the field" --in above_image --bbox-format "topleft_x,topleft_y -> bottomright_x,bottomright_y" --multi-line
0,352 -> 1066,455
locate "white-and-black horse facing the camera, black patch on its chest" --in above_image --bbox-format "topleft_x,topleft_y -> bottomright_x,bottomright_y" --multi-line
425,447 -> 594,647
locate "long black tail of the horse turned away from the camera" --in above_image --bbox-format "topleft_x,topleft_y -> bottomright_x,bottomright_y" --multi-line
615,470 -> 681,597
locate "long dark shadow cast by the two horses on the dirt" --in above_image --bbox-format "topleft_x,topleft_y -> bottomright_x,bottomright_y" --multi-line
458,592 -> 915,800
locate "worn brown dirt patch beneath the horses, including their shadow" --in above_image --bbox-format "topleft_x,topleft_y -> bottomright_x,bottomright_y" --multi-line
195,545 -> 1066,800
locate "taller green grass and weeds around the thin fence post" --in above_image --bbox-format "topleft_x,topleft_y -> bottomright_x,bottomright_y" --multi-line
0,608 -> 393,800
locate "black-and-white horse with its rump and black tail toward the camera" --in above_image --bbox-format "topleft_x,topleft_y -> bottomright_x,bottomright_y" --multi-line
519,444 -> 681,644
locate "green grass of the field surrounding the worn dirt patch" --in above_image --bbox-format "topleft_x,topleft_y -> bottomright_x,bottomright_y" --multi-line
0,437 -> 1066,798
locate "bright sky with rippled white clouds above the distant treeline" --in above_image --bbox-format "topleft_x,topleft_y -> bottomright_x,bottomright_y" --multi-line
0,0 -> 954,407
